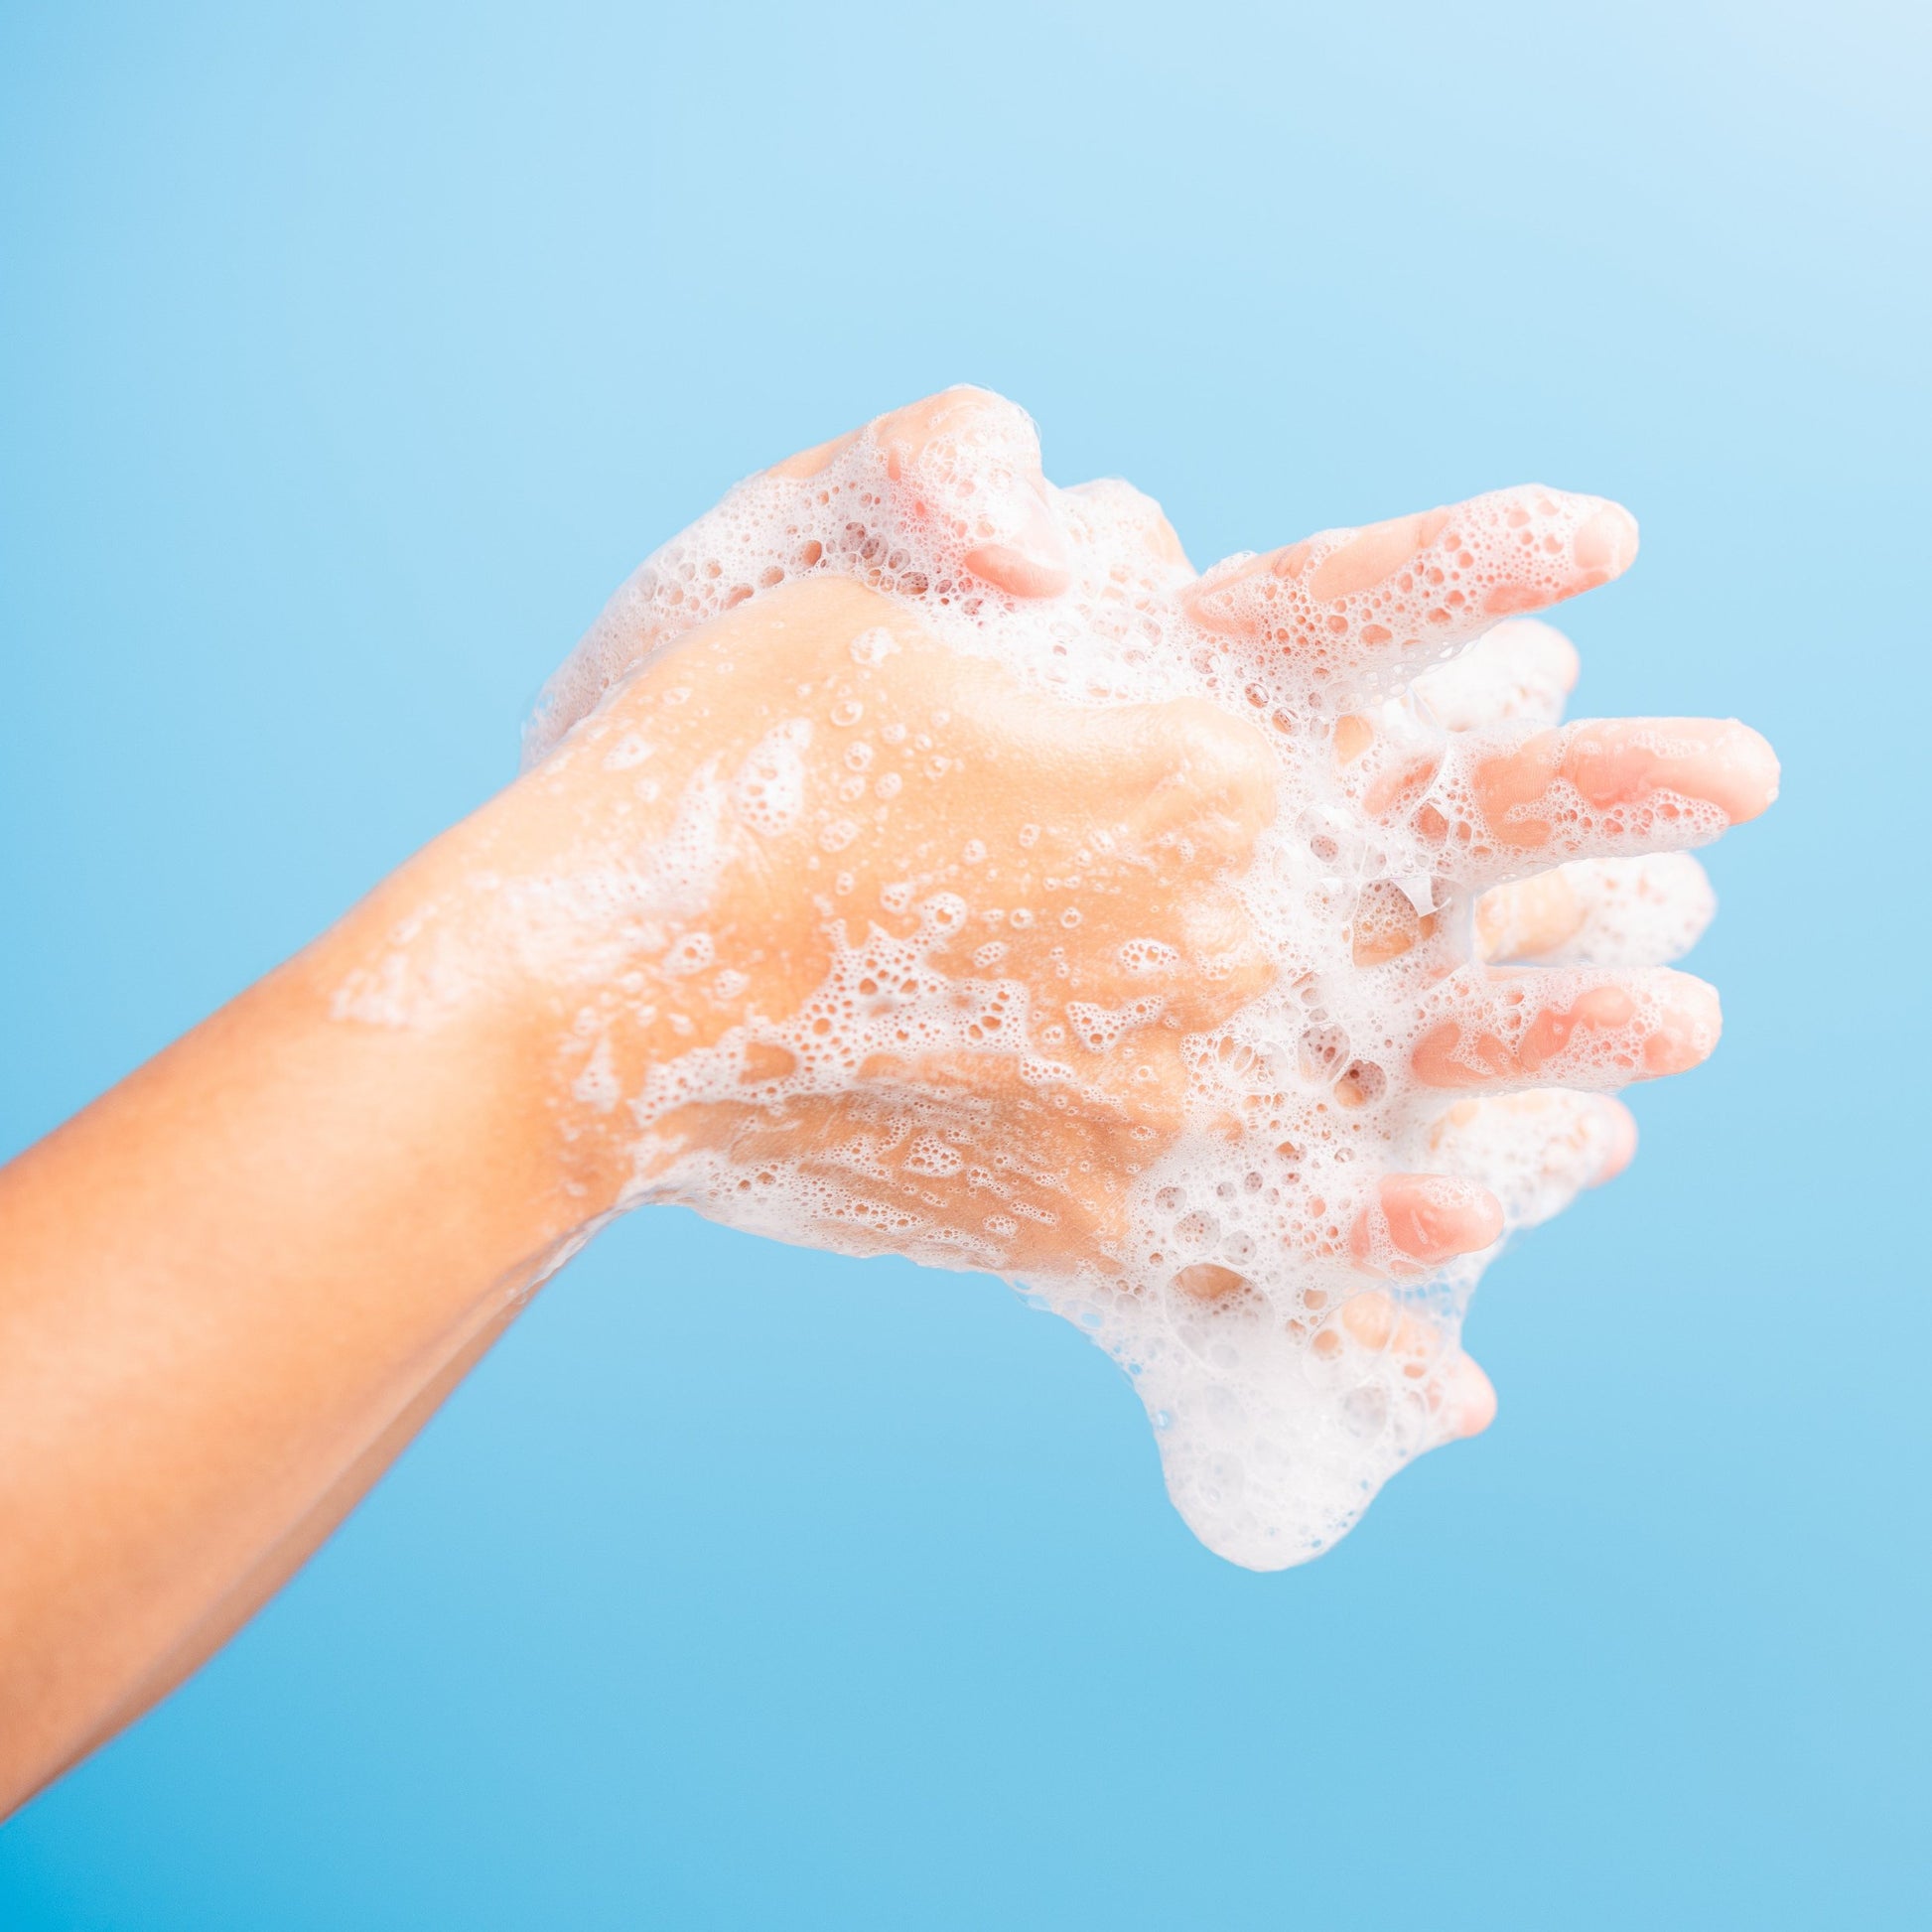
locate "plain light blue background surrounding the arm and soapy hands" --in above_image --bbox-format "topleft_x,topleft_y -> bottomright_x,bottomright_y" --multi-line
0,0 -> 1932,1932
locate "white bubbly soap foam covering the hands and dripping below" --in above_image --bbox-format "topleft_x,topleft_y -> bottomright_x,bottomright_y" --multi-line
517,398 -> 1722,1569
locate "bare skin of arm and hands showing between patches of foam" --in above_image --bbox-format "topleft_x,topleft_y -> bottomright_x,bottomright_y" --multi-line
0,390 -> 1775,1808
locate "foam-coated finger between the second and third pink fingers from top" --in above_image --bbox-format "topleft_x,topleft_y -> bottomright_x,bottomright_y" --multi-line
1476,852 -> 1718,966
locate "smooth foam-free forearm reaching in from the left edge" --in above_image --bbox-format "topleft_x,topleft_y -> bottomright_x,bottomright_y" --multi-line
0,848 -> 586,1808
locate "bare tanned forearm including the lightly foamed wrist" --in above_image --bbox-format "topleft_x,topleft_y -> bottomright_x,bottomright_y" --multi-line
0,575 -> 822,1810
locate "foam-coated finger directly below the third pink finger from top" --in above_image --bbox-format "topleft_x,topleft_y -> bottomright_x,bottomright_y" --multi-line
1430,1088 -> 1636,1229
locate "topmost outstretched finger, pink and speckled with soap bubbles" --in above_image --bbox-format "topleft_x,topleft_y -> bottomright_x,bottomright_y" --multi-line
1186,484 -> 1636,690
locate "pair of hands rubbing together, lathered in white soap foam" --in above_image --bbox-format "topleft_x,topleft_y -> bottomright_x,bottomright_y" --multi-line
380,390 -> 1775,1567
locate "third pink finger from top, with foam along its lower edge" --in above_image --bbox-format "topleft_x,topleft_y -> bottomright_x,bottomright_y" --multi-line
1409,966 -> 1724,1091
